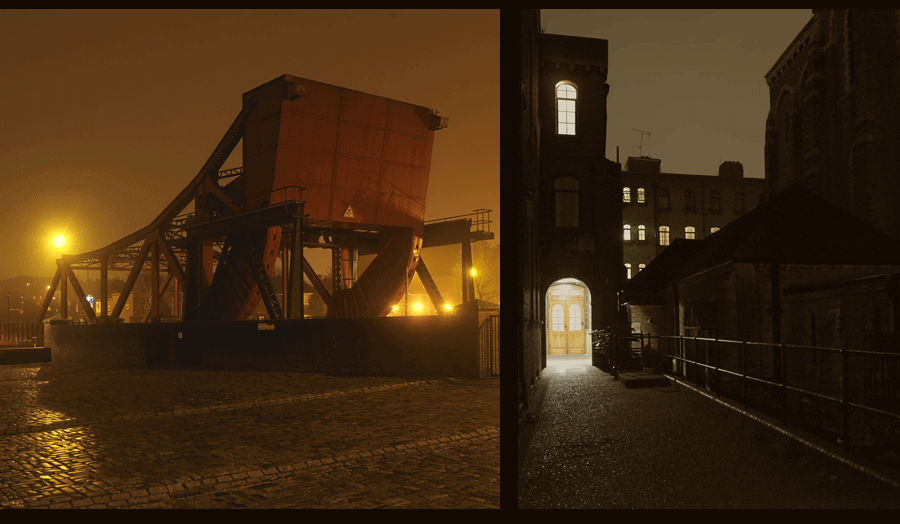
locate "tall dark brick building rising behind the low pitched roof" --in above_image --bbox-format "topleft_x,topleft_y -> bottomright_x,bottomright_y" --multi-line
765,9 -> 900,238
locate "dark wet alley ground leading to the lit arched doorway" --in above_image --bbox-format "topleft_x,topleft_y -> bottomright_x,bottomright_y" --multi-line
518,356 -> 900,509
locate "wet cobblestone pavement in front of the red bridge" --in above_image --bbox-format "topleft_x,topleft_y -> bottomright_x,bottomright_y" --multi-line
0,364 -> 500,508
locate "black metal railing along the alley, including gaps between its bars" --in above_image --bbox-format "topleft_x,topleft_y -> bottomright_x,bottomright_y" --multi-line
613,335 -> 900,451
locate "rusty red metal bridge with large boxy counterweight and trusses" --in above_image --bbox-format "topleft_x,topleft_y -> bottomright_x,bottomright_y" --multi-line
38,75 -> 493,323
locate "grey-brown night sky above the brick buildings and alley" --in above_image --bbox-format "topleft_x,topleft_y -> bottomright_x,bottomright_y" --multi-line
541,9 -> 813,178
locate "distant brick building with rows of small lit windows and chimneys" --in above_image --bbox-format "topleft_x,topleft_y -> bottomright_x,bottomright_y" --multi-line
622,157 -> 768,278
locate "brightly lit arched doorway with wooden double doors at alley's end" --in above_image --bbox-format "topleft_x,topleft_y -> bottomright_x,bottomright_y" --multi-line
544,278 -> 591,356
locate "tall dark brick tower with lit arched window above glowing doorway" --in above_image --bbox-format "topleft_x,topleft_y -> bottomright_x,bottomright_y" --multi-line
538,34 -> 624,364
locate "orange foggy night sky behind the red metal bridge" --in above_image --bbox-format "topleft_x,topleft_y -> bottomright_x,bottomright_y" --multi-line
0,10 -> 500,279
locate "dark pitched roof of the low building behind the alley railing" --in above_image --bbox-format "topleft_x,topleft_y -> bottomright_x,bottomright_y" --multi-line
625,185 -> 900,298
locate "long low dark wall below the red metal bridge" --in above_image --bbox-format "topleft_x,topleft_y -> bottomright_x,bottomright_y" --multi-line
45,308 -> 479,378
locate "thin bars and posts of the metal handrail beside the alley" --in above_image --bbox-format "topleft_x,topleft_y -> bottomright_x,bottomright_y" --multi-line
612,334 -> 900,452
